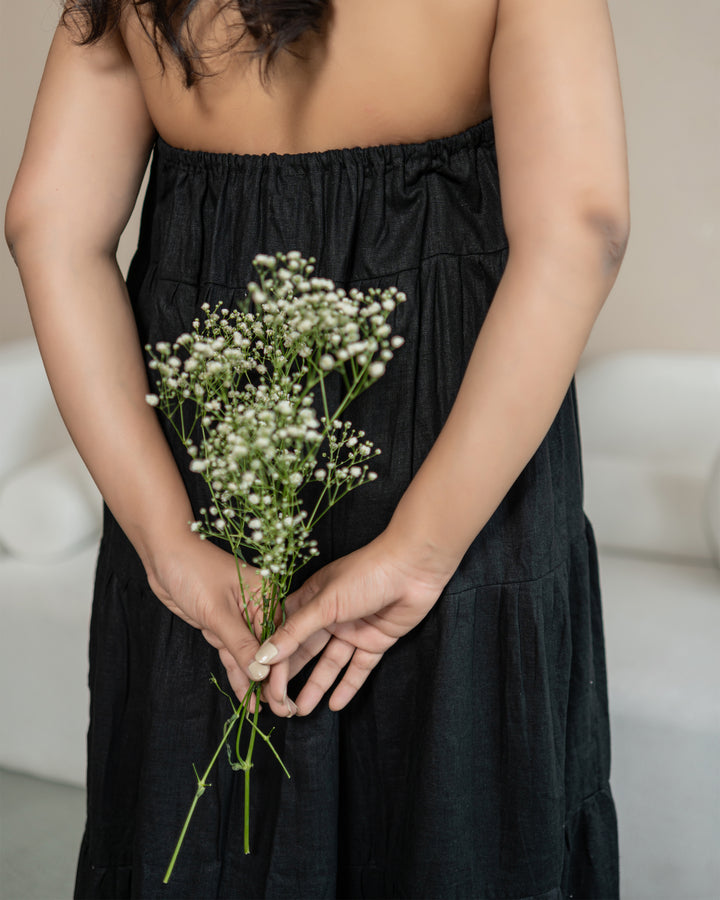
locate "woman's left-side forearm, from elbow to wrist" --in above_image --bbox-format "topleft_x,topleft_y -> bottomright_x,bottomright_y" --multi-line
13,236 -> 193,570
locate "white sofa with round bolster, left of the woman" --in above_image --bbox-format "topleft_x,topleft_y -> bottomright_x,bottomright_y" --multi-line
0,340 -> 102,784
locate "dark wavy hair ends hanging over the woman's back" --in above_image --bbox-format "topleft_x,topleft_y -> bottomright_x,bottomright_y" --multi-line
61,0 -> 329,88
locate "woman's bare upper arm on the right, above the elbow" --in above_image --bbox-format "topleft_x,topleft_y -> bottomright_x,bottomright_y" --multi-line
490,0 -> 629,255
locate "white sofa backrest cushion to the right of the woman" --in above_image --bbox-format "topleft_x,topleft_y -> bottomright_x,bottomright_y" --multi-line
576,351 -> 720,562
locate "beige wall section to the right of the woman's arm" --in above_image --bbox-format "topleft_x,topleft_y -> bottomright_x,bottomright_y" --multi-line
586,0 -> 720,356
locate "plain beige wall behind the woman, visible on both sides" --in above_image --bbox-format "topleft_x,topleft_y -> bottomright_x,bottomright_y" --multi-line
0,0 -> 720,357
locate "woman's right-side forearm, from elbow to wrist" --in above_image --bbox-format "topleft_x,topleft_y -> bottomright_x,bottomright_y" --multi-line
386,229 -> 622,575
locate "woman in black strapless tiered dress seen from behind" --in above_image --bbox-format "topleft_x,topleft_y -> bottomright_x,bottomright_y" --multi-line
6,0 -> 628,900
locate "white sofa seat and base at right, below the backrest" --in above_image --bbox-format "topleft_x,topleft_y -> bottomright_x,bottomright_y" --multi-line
600,552 -> 720,900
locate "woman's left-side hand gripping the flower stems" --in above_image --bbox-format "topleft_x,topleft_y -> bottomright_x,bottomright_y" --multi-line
148,535 -> 268,711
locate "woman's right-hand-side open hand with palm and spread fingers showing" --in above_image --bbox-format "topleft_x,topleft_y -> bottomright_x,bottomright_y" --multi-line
255,532 -> 454,716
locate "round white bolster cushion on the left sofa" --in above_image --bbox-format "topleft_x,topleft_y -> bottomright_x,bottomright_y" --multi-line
0,446 -> 102,563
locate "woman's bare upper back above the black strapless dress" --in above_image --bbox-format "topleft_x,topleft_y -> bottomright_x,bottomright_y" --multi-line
121,0 -> 497,153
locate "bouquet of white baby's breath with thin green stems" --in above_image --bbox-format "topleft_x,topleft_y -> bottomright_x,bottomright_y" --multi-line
146,251 -> 406,883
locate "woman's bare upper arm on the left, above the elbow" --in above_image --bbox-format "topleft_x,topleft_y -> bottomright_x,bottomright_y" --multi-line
5,16 -> 155,253
